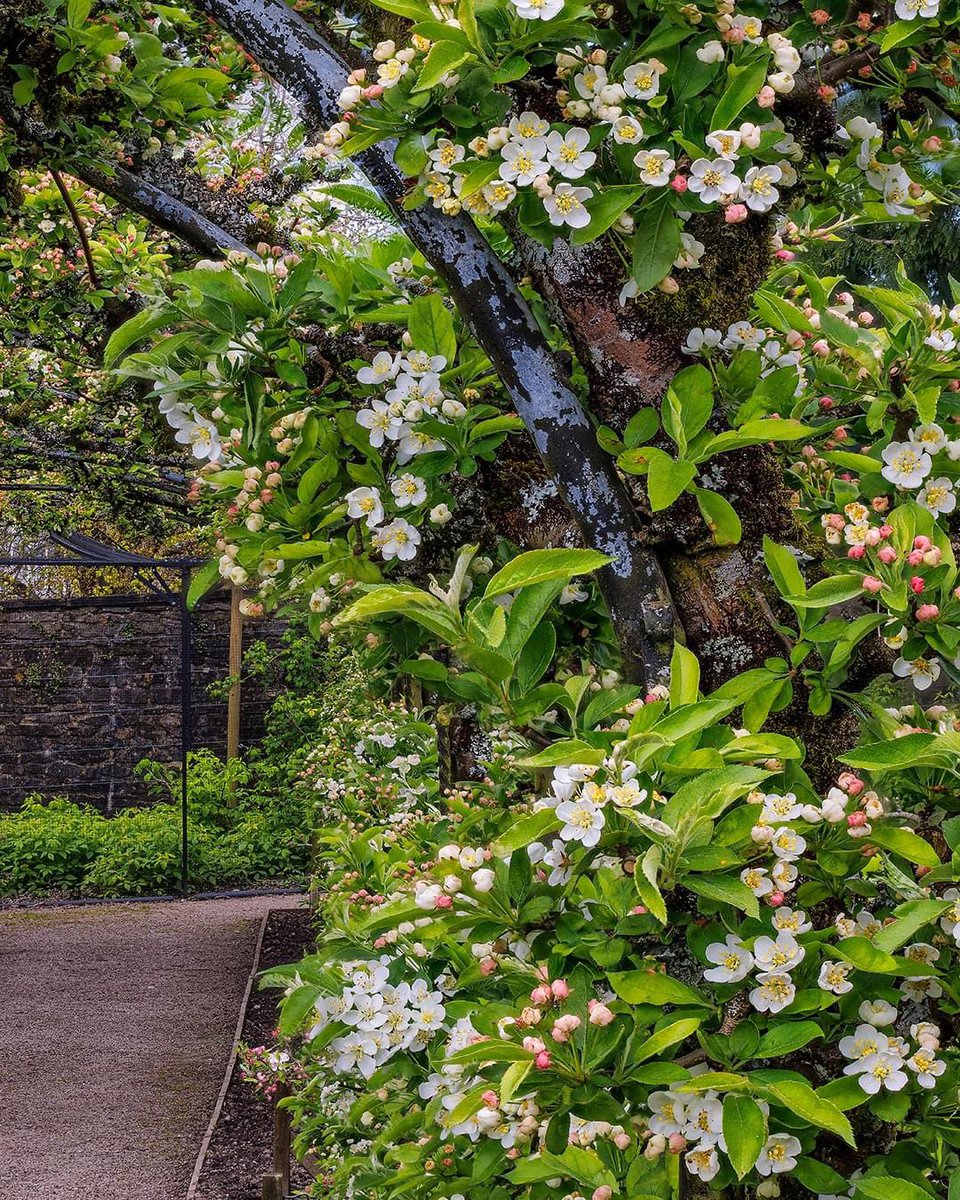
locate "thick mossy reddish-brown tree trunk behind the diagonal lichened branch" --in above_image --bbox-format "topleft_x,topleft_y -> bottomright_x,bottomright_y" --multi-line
508,216 -> 800,690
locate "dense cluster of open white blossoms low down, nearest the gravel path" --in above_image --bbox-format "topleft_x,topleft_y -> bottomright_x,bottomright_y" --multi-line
307,955 -> 446,1079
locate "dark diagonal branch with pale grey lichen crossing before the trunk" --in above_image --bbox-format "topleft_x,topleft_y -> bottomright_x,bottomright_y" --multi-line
202,0 -> 677,684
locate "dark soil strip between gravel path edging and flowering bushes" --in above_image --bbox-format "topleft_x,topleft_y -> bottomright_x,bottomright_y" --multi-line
194,908 -> 313,1200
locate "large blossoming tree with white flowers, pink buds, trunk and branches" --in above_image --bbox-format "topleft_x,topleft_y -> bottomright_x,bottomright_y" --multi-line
0,0 -> 960,1200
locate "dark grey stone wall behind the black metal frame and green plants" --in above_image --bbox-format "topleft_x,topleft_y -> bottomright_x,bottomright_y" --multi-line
0,596 -> 282,811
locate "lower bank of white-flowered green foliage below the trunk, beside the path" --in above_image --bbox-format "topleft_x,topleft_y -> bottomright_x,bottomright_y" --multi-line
220,551 -> 960,1200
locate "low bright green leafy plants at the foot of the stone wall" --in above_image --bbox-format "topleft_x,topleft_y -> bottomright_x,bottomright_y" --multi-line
0,623 -> 344,898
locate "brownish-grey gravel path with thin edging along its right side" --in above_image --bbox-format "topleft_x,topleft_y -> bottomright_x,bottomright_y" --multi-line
0,896 -> 300,1200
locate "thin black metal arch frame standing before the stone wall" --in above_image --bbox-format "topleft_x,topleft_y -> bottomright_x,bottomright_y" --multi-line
0,533 -> 204,896
